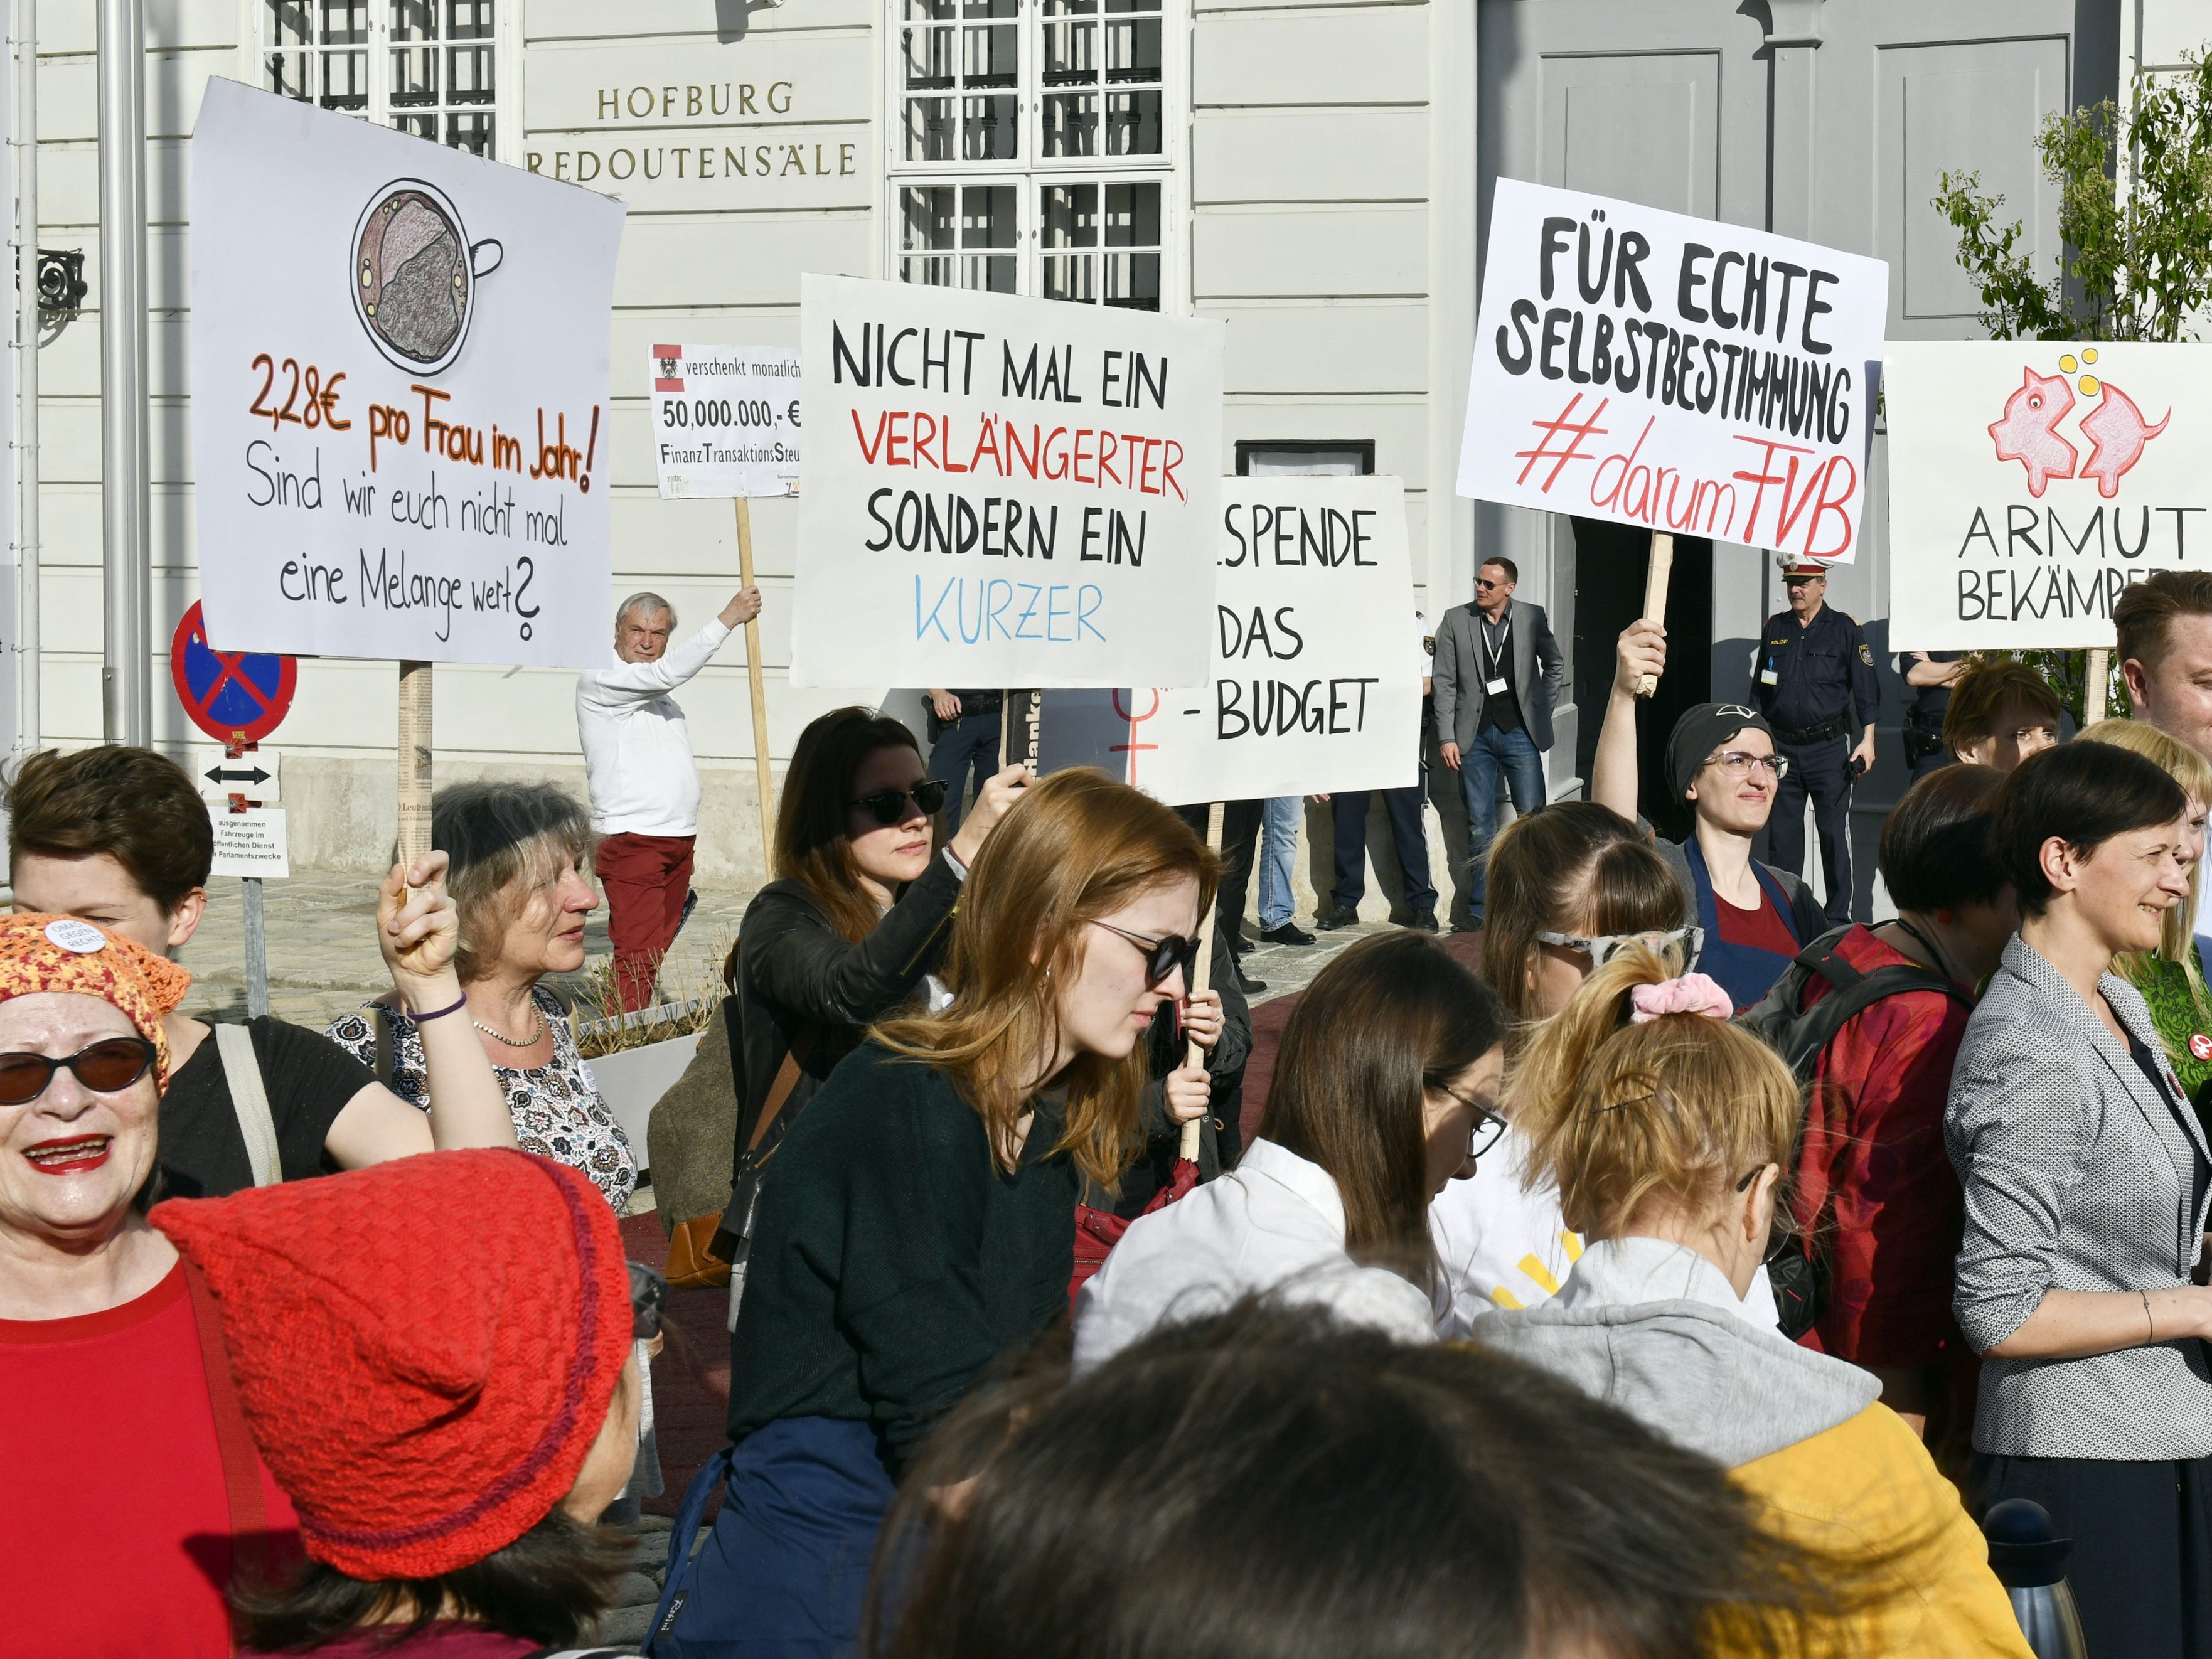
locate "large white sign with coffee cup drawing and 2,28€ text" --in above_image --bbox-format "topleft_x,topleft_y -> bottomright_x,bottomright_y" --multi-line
188,80 -> 622,668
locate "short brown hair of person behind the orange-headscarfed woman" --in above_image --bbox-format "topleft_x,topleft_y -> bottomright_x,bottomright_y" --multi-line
7,744 -> 215,914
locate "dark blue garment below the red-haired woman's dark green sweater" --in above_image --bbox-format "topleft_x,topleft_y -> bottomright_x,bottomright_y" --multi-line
644,1418 -> 896,1659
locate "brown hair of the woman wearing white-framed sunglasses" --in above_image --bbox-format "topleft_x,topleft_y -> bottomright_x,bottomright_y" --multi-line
1482,801 -> 1690,1024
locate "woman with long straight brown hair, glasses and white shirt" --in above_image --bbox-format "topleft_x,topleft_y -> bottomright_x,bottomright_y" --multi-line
1075,934 -> 1507,1369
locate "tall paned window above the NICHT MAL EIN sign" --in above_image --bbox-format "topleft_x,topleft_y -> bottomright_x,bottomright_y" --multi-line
887,0 -> 1172,312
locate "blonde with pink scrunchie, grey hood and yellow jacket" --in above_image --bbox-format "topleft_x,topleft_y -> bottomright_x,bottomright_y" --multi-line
1473,947 -> 2026,1659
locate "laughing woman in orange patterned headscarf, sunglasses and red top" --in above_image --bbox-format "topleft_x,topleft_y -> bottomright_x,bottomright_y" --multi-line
0,914 -> 299,1659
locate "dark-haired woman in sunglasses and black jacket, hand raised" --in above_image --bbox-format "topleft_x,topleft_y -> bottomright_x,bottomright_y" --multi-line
724,708 -> 1029,1239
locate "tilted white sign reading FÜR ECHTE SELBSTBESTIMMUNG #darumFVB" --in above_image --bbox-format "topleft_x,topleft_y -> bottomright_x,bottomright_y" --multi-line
1460,179 -> 1889,562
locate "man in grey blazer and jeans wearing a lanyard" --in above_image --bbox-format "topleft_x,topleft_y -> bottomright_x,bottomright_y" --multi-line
1433,557 -> 1566,927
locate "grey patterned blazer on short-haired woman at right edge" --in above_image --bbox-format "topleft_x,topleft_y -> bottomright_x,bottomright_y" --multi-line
1944,936 -> 2212,1460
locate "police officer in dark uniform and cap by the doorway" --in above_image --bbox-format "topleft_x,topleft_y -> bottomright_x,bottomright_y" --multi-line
1752,560 -> 1883,925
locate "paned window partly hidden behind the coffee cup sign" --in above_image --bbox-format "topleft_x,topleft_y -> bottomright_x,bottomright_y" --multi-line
261,0 -> 498,155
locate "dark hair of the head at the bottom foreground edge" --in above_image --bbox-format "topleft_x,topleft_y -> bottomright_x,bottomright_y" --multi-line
860,1303 -> 1874,1659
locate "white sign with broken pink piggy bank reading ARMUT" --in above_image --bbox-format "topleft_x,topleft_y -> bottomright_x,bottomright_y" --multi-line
1883,341 -> 2212,650
